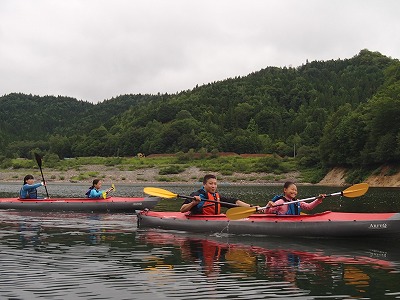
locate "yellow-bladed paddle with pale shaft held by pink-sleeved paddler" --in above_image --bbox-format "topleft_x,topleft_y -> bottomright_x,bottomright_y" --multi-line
226,183 -> 368,220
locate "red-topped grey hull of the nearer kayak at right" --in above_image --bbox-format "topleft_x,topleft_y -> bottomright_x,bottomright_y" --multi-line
138,211 -> 400,237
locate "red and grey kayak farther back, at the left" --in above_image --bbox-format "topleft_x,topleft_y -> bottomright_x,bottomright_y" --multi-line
0,197 -> 161,212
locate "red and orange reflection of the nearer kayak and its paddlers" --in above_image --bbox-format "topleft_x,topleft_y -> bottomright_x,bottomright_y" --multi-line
137,230 -> 398,294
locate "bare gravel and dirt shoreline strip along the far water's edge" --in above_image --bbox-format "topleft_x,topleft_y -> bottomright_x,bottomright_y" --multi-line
0,165 -> 400,187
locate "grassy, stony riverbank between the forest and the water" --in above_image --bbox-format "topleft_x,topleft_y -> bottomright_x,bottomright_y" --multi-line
0,151 -> 400,184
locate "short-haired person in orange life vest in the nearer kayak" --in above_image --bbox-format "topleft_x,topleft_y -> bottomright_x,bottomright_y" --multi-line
180,174 -> 252,215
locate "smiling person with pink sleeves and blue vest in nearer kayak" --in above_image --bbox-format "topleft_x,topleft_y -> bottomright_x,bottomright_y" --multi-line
265,181 -> 326,215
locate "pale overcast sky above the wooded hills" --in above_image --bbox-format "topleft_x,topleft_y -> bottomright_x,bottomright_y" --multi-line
0,0 -> 400,103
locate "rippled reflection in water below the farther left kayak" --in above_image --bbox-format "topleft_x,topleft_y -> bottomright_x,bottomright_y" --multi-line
0,211 -> 136,252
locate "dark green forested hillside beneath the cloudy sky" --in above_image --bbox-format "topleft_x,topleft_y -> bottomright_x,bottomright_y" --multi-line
0,50 -> 400,171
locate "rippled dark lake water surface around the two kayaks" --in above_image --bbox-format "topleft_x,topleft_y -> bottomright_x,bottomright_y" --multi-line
0,184 -> 400,300
